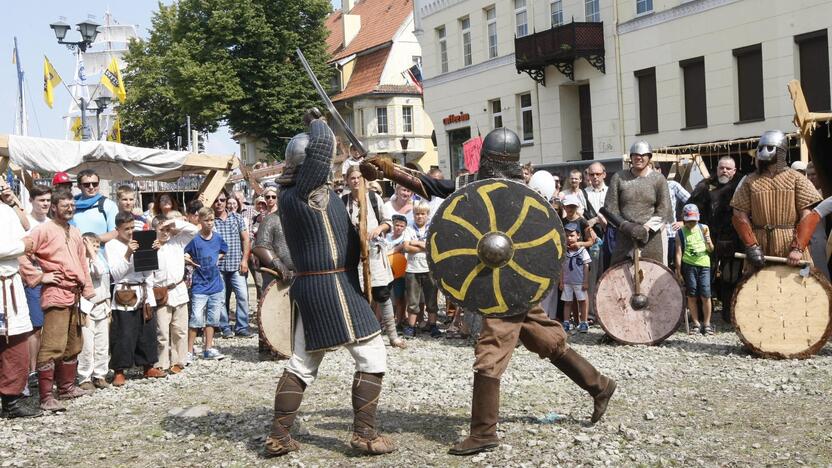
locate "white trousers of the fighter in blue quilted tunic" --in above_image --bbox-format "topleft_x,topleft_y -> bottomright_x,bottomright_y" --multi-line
286,316 -> 387,386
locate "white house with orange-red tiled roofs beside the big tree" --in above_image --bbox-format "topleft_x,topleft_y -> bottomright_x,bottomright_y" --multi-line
326,0 -> 437,170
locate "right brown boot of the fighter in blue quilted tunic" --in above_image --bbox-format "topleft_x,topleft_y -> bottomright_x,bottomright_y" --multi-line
350,372 -> 396,455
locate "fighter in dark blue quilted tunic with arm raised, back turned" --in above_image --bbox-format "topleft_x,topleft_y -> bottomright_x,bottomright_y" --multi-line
261,109 -> 395,456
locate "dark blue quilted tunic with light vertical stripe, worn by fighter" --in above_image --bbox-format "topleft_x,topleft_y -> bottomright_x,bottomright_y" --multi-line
279,120 -> 380,351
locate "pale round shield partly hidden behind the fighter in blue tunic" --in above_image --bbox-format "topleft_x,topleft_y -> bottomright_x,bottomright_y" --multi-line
257,281 -> 294,359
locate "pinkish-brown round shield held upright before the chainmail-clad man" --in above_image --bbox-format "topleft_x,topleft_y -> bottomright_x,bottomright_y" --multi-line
595,257 -> 685,345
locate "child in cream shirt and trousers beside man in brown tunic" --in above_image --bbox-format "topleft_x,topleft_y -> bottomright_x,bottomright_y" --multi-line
78,232 -> 110,391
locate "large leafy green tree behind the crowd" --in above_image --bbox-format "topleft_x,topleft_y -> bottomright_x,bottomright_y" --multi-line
121,0 -> 332,158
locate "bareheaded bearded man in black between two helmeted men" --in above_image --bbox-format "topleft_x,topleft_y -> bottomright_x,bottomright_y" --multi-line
688,156 -> 743,323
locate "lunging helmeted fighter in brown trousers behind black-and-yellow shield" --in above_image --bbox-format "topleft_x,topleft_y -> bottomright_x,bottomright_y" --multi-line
361,128 -> 616,455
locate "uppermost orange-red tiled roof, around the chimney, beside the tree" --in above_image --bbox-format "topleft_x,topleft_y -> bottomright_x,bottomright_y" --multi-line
326,0 -> 413,60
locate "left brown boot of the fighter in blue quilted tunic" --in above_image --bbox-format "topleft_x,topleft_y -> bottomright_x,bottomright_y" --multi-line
265,370 -> 306,457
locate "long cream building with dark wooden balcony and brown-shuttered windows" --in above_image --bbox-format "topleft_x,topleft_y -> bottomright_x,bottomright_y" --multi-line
414,0 -> 832,172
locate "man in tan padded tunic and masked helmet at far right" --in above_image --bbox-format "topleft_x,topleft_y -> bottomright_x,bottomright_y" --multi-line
731,130 -> 821,269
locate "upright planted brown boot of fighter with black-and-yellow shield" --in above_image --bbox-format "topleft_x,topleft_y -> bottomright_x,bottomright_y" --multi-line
448,374 -> 500,455
